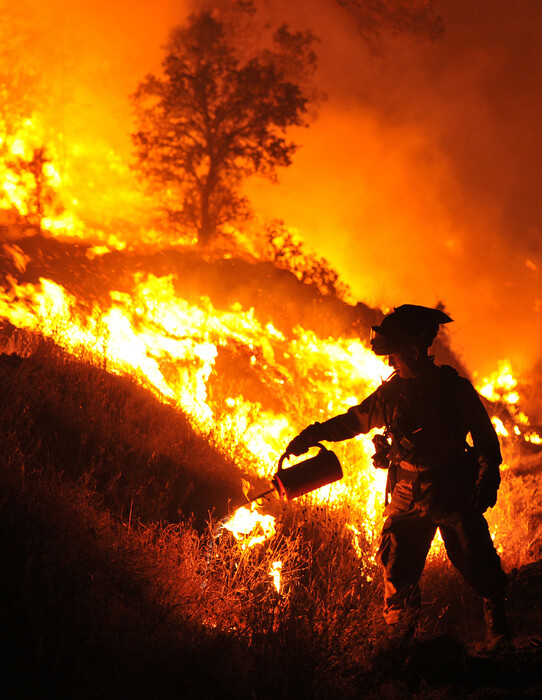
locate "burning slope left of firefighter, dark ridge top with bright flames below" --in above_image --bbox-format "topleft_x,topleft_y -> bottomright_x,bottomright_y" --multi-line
3,239 -> 389,504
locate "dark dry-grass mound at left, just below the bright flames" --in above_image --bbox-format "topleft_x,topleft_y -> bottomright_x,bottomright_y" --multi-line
0,342 -> 250,527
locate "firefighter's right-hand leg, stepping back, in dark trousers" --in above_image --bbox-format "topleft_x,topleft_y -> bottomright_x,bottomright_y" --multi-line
440,510 -> 510,650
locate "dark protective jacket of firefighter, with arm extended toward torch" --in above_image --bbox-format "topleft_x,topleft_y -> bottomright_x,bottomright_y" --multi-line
299,362 -> 502,511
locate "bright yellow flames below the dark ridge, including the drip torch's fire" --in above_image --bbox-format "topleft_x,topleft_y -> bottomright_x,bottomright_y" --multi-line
0,266 -> 541,568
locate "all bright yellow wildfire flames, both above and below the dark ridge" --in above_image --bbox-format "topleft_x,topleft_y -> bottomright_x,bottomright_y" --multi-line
0,83 -> 542,592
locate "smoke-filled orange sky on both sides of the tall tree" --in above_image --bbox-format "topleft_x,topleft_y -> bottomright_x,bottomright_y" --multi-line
7,0 -> 542,372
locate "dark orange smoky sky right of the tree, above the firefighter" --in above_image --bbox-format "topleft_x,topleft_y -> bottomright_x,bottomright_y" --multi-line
246,0 -> 542,378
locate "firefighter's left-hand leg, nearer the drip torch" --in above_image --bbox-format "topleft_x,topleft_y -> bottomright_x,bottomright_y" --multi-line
377,511 -> 436,625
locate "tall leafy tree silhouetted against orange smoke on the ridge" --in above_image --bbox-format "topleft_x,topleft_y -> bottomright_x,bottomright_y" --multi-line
133,2 -> 316,246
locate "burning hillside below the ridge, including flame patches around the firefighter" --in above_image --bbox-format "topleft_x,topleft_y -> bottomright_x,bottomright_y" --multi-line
1,232 -> 541,560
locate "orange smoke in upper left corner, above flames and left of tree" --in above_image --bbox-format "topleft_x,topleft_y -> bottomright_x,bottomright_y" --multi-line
7,0 -> 191,153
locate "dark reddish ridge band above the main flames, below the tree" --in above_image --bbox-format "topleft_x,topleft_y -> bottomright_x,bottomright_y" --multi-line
0,234 -> 460,366
